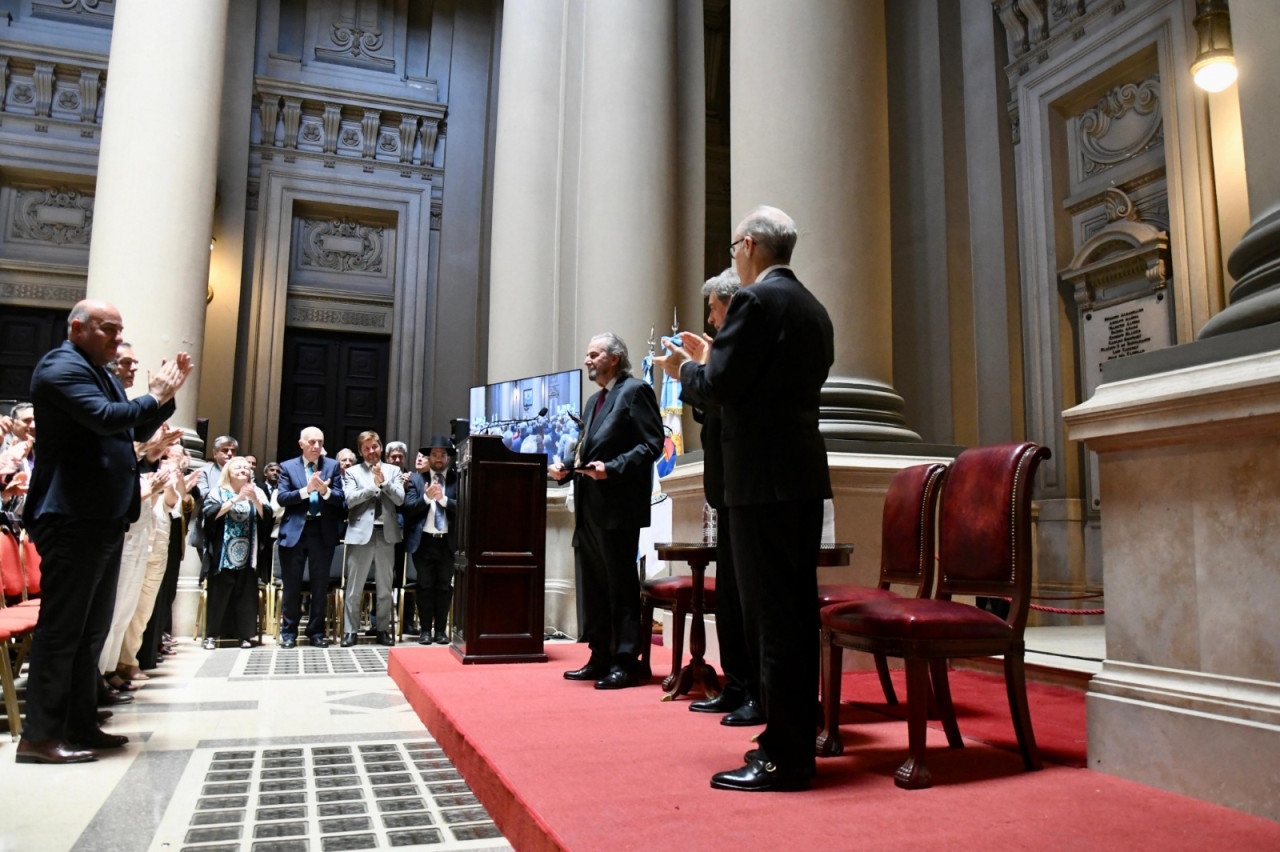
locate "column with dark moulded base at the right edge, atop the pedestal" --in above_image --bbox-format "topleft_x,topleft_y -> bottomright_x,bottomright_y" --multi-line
1199,0 -> 1280,339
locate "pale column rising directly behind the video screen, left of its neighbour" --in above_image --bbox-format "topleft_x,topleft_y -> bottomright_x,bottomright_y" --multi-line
489,0 -> 572,381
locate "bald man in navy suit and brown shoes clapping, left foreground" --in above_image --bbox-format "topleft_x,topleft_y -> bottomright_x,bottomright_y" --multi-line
17,299 -> 192,764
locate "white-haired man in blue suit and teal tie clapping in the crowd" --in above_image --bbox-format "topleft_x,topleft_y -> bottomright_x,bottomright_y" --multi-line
275,426 -> 347,647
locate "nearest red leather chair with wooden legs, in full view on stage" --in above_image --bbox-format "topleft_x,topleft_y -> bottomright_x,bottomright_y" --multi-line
822,443 -> 1048,789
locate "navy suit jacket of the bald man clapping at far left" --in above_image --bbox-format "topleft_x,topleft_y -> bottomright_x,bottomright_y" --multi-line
22,340 -> 174,526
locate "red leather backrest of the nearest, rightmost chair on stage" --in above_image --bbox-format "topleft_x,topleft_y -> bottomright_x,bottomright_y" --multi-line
937,441 -> 1050,629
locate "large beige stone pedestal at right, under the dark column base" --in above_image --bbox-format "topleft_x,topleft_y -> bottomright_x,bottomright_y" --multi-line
1064,344 -> 1280,819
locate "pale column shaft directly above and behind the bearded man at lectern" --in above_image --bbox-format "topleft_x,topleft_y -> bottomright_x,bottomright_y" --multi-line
576,0 -> 687,360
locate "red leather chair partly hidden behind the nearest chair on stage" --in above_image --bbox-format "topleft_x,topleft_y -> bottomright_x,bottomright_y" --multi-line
818,463 -> 947,711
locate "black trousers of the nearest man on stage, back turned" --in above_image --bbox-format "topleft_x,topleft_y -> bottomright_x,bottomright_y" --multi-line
732,500 -> 822,773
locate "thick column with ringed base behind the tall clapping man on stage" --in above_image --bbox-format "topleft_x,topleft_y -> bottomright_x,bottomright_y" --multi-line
724,0 -> 919,441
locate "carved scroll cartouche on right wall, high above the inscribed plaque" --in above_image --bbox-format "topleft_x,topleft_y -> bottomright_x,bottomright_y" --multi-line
1075,74 -> 1164,175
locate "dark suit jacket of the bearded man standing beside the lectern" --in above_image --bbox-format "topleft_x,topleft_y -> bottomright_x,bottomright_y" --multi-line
573,375 -> 662,539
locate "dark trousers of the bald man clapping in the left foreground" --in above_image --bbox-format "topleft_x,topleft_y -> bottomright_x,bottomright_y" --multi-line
23,514 -> 128,739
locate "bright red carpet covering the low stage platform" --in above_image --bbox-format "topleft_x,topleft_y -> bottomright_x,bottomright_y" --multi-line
389,643 -> 1280,852
